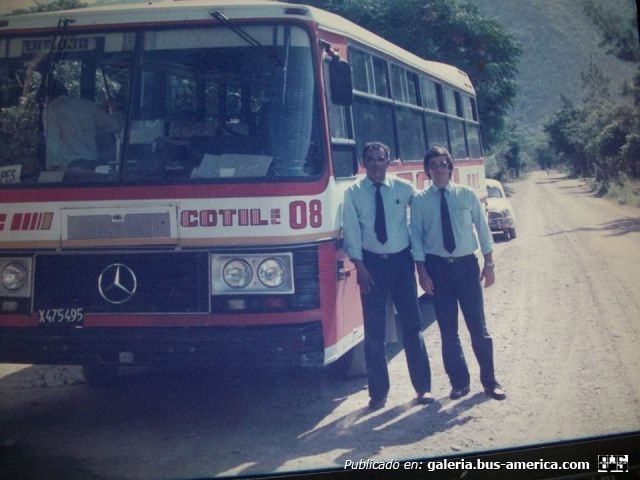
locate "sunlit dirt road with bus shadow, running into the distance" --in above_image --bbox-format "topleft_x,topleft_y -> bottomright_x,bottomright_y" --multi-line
0,172 -> 640,480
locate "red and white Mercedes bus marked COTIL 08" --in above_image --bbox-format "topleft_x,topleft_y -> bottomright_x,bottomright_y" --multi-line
0,0 -> 486,382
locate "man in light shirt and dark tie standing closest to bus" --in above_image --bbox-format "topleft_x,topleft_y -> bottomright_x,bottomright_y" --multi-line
343,142 -> 434,410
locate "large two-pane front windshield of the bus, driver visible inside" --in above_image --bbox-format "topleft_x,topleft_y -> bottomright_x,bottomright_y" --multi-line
0,25 -> 323,188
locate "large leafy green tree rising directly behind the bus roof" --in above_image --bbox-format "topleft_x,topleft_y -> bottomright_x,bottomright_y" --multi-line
288,0 -> 522,147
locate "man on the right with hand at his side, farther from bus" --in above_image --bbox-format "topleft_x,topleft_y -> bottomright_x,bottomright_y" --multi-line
411,146 -> 506,400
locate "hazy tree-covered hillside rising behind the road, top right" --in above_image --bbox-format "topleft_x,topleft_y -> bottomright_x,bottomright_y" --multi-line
468,0 -> 640,129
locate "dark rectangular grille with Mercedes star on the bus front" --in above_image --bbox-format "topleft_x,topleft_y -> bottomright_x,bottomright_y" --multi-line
34,252 -> 209,313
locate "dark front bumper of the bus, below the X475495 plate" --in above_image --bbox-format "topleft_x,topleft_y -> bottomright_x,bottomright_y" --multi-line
0,321 -> 324,367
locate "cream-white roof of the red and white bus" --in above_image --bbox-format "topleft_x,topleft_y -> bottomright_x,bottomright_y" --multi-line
0,0 -> 475,95
